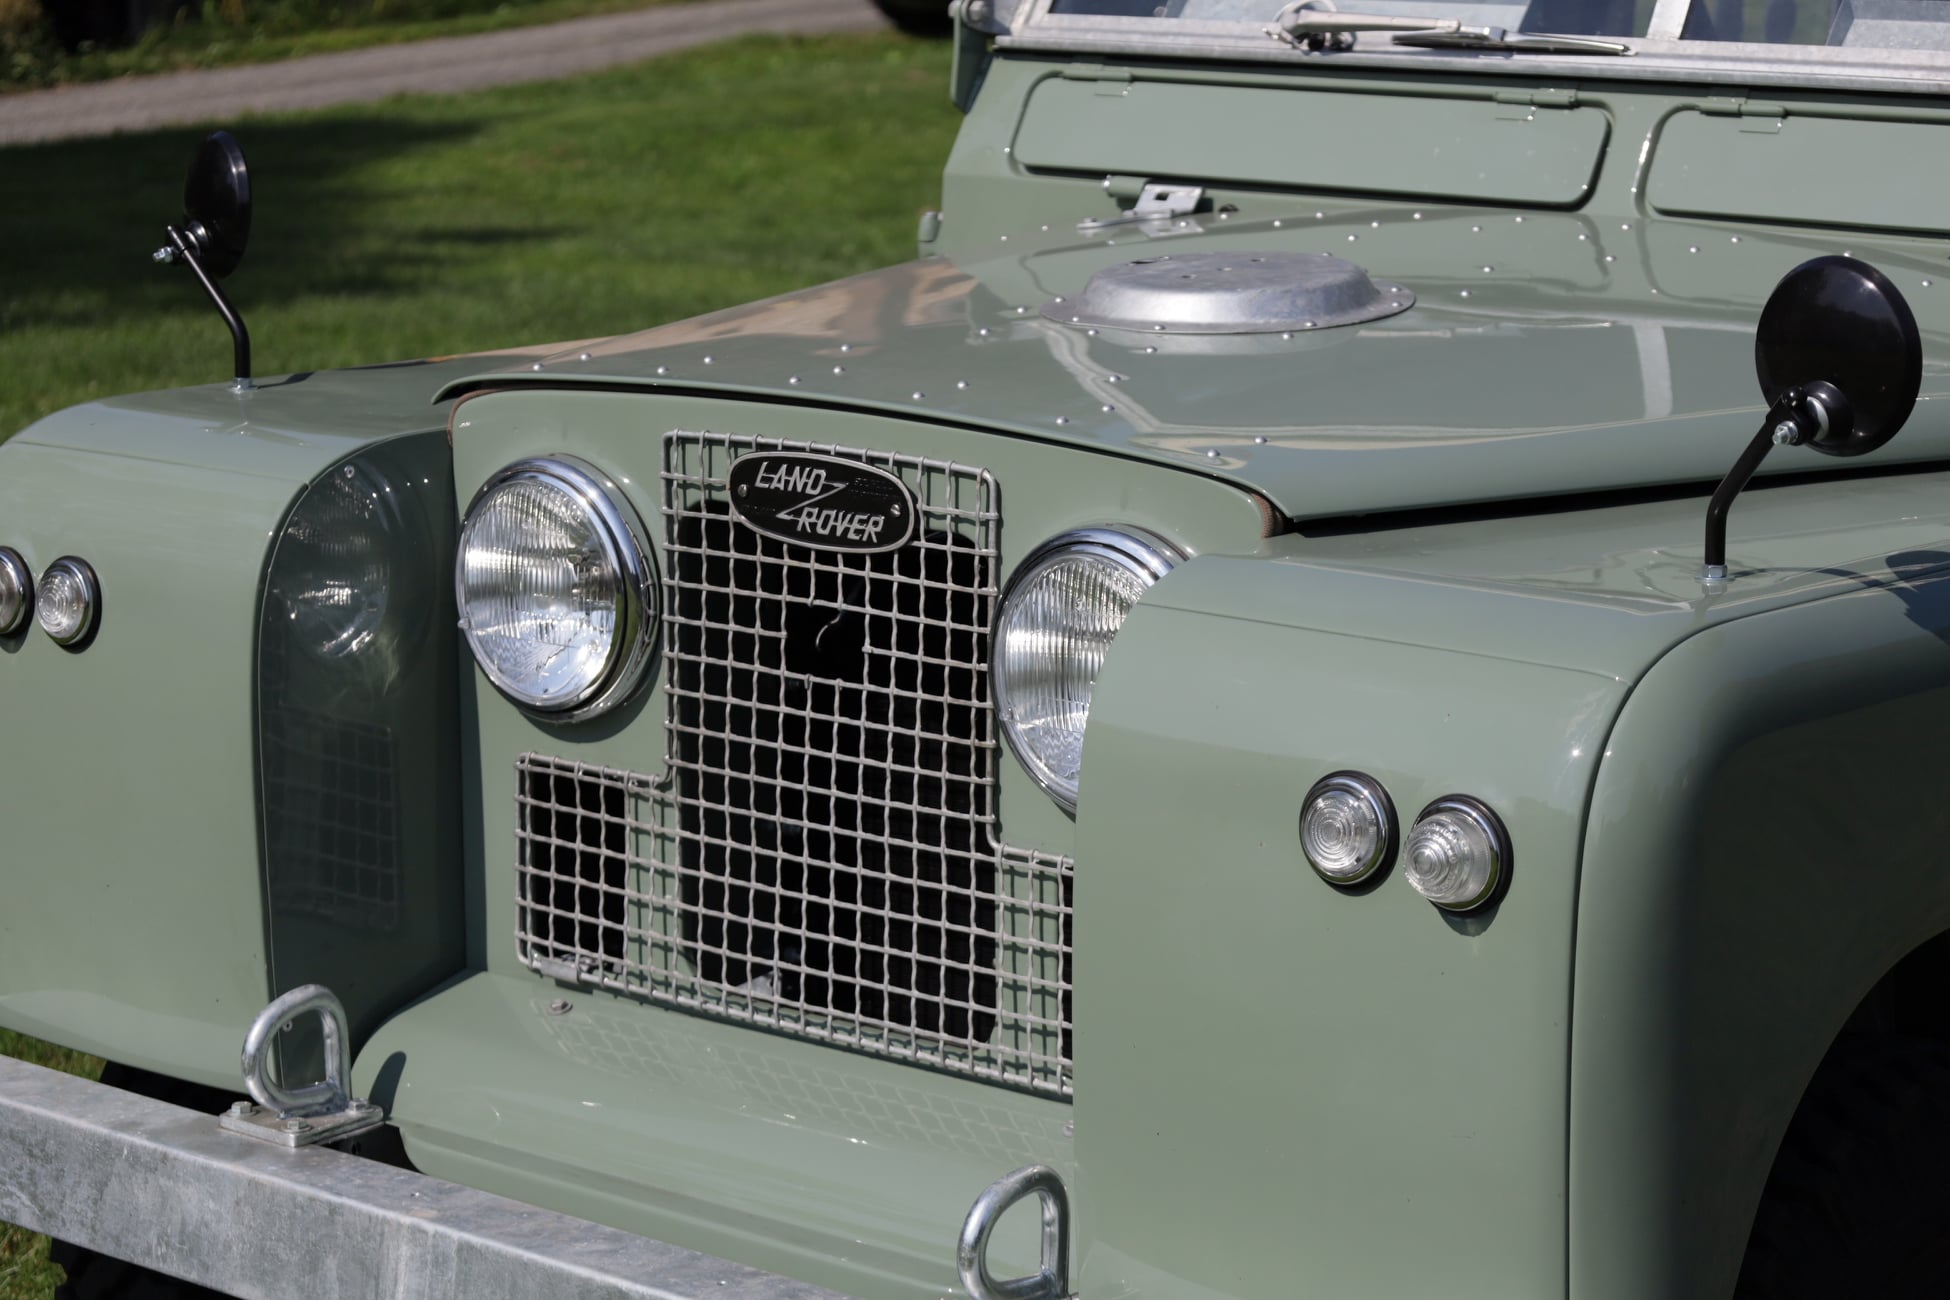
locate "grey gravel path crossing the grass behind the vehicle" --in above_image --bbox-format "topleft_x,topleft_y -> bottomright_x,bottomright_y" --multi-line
0,0 -> 885,144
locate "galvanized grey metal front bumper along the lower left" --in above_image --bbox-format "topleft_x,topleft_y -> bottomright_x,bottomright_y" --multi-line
0,1058 -> 842,1300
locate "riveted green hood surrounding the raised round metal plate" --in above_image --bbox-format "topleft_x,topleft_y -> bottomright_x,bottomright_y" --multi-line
443,207 -> 1950,518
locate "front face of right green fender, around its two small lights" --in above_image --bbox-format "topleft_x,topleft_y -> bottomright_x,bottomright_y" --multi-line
1076,557 -> 1624,1298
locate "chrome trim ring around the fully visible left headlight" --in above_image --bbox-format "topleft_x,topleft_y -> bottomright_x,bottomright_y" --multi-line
454,456 -> 661,723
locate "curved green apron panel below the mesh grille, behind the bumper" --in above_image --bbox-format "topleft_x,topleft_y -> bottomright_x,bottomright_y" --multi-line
357,970 -> 1074,1300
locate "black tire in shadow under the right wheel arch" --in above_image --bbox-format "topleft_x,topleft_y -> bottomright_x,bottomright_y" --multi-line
1734,1035 -> 1950,1300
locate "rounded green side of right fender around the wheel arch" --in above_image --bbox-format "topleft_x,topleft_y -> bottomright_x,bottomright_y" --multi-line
1570,576 -> 1950,1300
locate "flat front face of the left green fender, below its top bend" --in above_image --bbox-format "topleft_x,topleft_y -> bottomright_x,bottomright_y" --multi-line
0,439 -> 293,1082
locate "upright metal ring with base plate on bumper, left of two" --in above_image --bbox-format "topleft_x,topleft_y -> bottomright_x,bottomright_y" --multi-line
218,984 -> 386,1146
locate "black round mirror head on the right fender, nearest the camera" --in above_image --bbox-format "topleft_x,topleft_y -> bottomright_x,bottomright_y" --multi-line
1753,257 -> 1923,456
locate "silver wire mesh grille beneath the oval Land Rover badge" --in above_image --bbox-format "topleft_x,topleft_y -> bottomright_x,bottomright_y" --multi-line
519,433 -> 1071,1091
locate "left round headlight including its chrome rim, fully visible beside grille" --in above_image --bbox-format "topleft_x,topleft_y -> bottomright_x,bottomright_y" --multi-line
454,458 -> 657,721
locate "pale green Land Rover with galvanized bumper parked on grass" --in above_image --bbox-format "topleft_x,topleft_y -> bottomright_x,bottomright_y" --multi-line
0,0 -> 1950,1300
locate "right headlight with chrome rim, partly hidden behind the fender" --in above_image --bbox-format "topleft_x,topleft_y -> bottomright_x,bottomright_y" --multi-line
995,528 -> 1182,811
